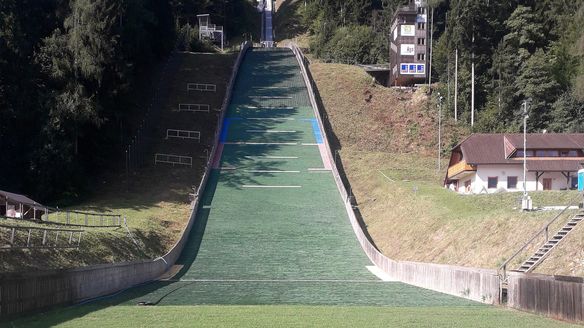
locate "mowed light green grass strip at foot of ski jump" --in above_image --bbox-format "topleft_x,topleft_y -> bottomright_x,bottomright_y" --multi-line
11,305 -> 578,328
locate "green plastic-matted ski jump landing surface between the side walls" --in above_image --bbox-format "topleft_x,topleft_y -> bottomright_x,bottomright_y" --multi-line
21,48 -> 483,311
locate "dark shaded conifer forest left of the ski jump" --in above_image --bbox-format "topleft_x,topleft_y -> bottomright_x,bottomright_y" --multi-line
0,0 -> 254,202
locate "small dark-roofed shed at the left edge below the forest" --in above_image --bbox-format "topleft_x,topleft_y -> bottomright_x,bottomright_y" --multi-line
0,190 -> 49,220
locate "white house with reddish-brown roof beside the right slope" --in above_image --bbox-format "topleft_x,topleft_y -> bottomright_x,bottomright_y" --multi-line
445,133 -> 584,194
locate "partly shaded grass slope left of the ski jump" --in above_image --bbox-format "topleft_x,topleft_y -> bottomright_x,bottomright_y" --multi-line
0,53 -> 235,272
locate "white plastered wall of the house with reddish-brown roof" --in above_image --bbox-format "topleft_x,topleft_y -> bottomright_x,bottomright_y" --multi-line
458,164 -> 576,194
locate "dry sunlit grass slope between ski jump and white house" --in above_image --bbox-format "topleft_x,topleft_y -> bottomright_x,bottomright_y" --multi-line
310,61 -> 584,275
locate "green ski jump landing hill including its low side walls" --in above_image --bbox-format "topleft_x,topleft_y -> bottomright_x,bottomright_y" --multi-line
0,44 -> 580,326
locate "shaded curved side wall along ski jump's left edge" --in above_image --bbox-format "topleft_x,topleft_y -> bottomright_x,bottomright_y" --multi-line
0,43 -> 251,318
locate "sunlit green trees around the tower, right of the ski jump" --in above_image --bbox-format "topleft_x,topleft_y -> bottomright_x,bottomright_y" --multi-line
299,0 -> 584,132
